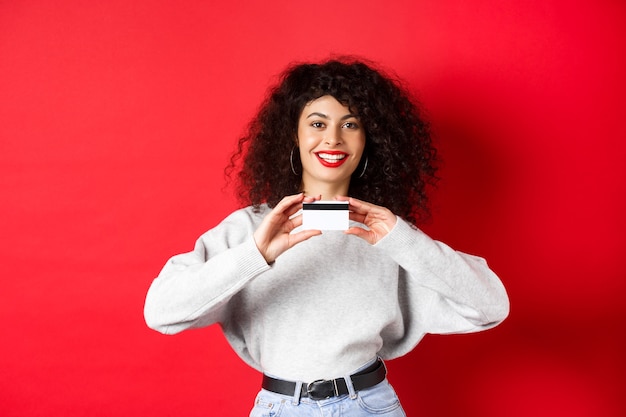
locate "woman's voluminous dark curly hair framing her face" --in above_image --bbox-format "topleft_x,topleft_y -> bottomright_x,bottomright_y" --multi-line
226,57 -> 437,225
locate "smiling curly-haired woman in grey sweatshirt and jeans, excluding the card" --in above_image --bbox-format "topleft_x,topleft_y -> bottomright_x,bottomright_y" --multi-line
145,59 -> 509,416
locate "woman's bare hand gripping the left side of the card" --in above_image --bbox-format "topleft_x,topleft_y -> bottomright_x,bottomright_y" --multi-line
253,193 -> 322,264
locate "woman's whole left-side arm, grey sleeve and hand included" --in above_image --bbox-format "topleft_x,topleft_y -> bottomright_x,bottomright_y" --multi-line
144,194 -> 321,334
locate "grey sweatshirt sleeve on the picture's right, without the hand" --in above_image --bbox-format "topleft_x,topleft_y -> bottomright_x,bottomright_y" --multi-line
376,218 -> 509,334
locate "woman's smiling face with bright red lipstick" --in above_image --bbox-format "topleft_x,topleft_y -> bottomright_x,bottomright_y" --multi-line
298,96 -> 365,192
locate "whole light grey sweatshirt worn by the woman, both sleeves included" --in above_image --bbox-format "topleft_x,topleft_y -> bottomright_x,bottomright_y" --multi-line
144,206 -> 509,382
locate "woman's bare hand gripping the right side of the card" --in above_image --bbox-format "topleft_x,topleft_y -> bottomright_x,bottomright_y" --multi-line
337,197 -> 397,245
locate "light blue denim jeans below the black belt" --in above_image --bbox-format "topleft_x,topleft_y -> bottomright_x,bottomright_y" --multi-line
250,379 -> 406,417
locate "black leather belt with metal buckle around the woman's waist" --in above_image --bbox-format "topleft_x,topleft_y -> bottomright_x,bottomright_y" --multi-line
262,359 -> 387,401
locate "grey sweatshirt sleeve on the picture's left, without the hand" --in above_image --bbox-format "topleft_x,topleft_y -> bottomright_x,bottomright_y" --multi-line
144,211 -> 270,334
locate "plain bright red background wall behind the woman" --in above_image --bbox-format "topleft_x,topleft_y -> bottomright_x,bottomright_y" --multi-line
0,0 -> 626,417
